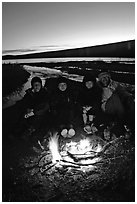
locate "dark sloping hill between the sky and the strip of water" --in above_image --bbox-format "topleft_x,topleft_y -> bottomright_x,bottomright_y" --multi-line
2,40 -> 135,60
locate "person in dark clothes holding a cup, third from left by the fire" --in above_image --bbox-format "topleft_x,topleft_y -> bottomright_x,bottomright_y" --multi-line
78,74 -> 102,133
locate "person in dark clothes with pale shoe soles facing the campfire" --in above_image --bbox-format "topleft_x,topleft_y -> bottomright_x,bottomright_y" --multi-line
50,76 -> 75,137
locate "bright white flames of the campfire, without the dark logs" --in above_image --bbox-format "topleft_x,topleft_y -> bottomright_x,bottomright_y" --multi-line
49,133 -> 102,170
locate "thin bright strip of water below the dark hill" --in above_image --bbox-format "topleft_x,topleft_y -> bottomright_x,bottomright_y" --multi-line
2,57 -> 135,64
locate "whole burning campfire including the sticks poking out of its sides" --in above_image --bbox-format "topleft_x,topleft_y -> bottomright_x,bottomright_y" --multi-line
29,133 -> 127,174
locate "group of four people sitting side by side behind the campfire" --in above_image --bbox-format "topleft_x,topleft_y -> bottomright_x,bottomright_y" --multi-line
16,72 -> 134,140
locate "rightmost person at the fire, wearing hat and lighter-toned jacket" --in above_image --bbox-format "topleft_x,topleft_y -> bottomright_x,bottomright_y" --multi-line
98,72 -> 134,137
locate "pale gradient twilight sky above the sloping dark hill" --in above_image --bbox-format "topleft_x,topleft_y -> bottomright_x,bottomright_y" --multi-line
2,2 -> 135,54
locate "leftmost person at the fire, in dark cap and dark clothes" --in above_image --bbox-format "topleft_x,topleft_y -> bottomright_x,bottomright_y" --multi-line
15,77 -> 49,135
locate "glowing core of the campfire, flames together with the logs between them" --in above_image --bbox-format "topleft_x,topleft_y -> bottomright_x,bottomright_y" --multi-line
49,133 -> 102,171
